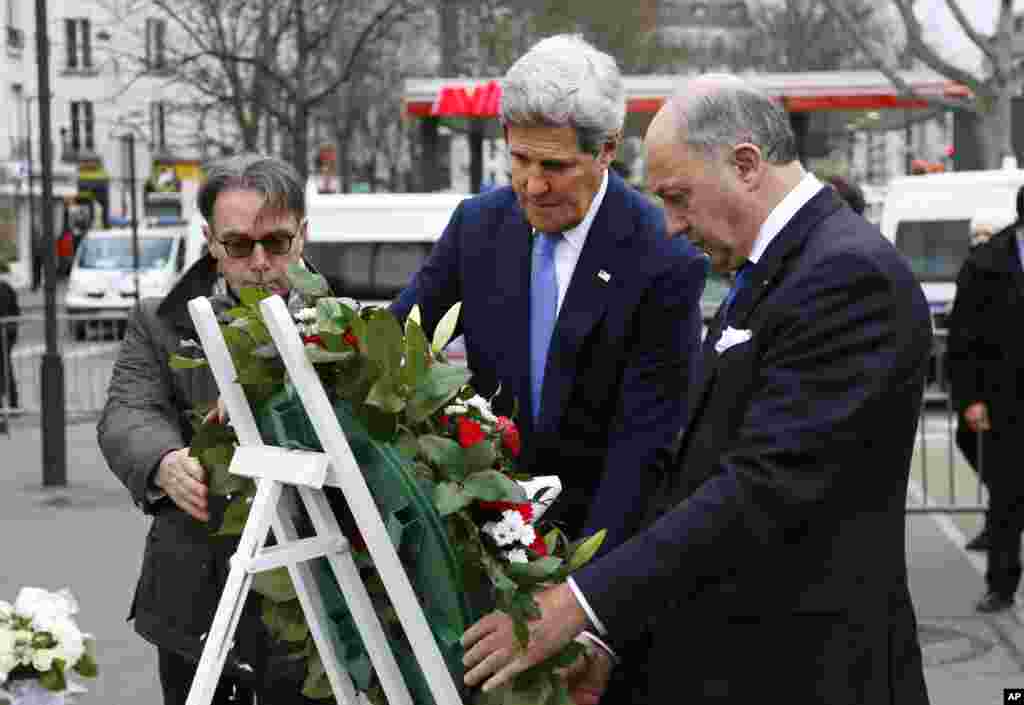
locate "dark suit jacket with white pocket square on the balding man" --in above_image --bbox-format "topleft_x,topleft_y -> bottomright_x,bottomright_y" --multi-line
575,189 -> 931,705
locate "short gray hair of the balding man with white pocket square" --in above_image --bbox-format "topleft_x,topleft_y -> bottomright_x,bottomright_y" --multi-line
676,74 -> 799,164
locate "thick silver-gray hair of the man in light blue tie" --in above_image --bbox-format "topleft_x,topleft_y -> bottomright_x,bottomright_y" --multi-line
501,34 -> 626,156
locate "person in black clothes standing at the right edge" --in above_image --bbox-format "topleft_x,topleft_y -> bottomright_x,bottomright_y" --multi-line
947,186 -> 1024,613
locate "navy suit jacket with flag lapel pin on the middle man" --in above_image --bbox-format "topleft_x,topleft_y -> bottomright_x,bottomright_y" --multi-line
393,174 -> 707,549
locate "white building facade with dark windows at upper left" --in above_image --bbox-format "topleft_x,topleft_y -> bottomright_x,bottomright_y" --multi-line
0,0 -> 209,286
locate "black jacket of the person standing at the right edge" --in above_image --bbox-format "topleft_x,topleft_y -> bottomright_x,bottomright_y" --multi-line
946,223 -> 1024,488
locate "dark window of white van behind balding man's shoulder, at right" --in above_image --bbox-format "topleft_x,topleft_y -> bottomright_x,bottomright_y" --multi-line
896,220 -> 971,282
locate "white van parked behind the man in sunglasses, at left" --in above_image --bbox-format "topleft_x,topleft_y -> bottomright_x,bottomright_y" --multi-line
65,223 -> 187,339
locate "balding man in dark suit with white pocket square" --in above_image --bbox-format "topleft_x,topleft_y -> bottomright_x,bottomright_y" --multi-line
463,76 -> 932,705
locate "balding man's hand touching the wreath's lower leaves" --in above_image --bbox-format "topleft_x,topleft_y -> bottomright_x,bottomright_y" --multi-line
462,583 -> 587,691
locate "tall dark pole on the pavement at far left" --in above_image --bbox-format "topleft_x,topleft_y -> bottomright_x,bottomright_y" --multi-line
36,0 -> 68,487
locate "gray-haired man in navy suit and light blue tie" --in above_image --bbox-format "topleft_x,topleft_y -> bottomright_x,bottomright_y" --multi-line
393,36 -> 707,548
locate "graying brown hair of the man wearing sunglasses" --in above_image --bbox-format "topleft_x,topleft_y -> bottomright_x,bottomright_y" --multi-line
197,154 -> 306,225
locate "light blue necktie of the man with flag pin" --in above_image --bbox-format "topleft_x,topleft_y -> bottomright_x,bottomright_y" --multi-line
529,233 -> 562,424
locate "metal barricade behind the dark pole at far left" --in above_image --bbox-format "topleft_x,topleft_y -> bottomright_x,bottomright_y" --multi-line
0,314 -> 128,424
